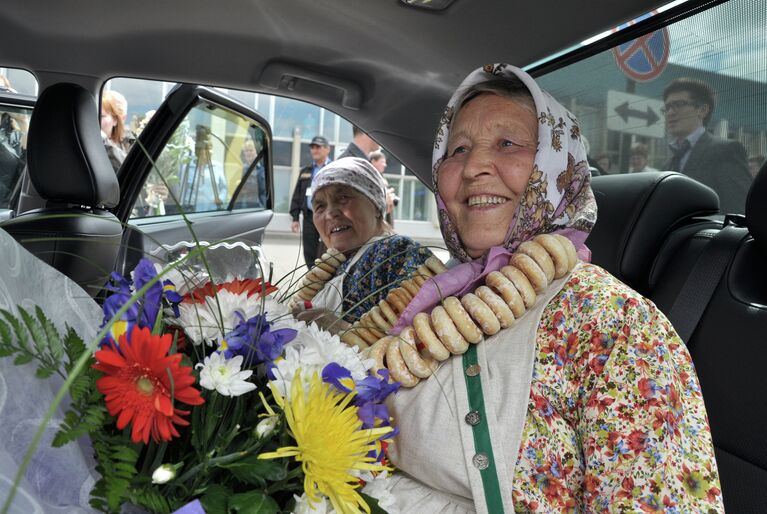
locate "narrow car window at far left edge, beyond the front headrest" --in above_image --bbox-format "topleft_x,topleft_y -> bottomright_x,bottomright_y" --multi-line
0,68 -> 37,209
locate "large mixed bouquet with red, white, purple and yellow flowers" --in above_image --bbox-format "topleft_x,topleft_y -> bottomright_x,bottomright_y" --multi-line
0,244 -> 399,514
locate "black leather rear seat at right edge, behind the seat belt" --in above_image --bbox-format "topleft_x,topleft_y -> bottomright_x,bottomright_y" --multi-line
651,165 -> 767,513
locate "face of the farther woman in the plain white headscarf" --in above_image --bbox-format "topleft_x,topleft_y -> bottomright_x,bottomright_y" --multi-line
312,184 -> 383,252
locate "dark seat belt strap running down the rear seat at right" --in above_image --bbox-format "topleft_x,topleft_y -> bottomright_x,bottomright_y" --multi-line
669,214 -> 748,344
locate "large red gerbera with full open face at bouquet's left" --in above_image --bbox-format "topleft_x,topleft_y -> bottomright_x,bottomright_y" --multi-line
93,327 -> 205,443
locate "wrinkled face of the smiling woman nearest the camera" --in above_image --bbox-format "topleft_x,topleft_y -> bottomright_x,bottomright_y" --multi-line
437,94 -> 538,258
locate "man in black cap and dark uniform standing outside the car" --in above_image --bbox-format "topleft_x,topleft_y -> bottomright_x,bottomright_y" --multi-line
290,136 -> 330,268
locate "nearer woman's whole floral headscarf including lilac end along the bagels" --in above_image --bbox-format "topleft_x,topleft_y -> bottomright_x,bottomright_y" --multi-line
390,64 -> 597,334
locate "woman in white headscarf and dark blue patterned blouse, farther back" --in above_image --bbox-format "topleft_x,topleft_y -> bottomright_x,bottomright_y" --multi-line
302,157 -> 432,328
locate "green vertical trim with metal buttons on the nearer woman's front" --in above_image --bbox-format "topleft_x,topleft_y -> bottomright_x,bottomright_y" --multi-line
463,344 -> 503,514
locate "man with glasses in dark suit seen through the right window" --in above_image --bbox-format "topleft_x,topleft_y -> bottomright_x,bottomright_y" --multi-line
663,78 -> 751,214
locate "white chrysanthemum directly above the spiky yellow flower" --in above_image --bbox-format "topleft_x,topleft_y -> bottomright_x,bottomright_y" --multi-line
272,323 -> 373,399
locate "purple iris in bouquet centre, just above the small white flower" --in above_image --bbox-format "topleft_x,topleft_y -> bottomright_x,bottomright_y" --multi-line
222,313 -> 297,367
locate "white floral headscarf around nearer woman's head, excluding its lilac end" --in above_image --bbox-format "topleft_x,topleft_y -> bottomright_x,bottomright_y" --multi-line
432,64 -> 597,262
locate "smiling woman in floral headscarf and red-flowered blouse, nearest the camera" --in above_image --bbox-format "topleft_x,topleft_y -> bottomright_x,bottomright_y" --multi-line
390,64 -> 723,514
